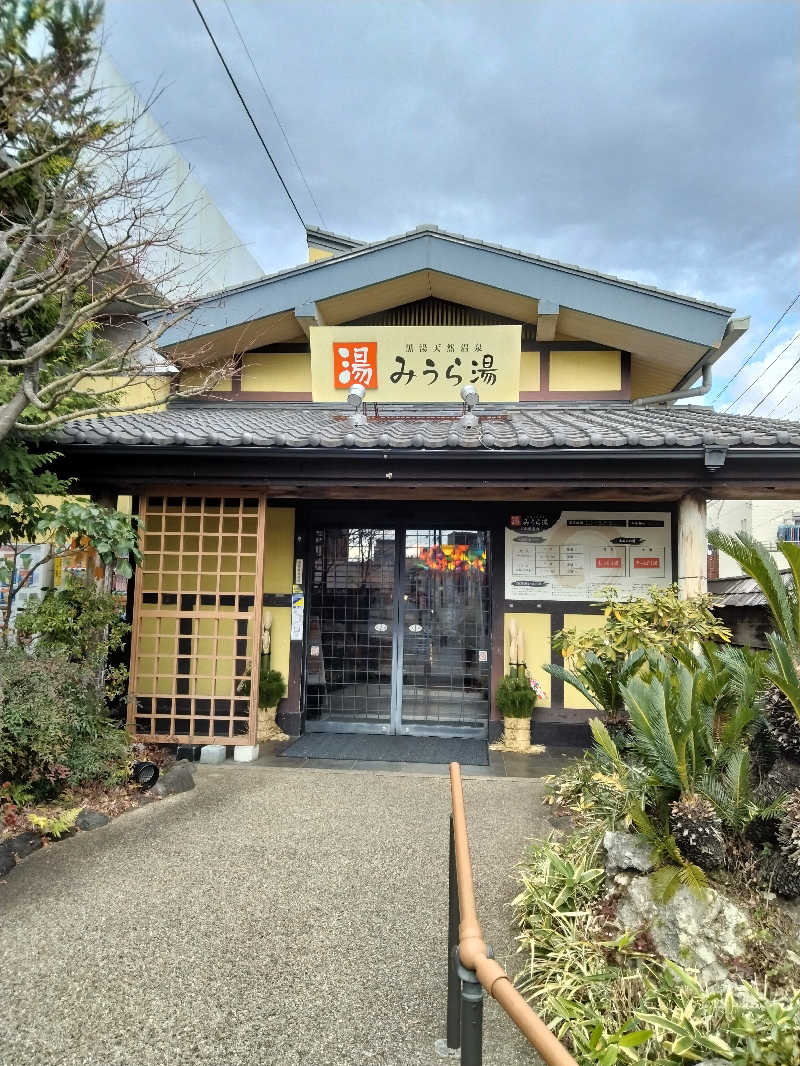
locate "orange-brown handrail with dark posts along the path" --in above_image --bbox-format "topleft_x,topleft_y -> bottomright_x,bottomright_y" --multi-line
441,762 -> 577,1066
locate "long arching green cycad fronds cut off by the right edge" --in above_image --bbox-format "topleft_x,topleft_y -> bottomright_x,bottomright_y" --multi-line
708,530 -> 800,723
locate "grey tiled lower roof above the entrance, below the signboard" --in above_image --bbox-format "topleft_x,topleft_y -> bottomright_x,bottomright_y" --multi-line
53,401 -> 800,449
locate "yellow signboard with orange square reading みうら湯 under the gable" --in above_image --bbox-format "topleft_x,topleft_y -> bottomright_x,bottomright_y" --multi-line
310,325 -> 523,403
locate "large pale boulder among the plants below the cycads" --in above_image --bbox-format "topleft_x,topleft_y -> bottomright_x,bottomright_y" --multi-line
617,877 -> 749,984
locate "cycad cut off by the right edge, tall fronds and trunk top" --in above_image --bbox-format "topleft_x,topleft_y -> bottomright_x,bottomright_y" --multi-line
708,531 -> 800,760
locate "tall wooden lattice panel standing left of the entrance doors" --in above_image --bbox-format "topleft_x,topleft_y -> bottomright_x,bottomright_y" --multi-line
128,495 -> 266,744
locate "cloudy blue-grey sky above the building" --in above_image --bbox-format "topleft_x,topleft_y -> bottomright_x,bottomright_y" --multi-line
106,0 -> 800,418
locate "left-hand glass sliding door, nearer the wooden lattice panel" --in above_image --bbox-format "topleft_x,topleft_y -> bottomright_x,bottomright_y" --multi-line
305,527 -> 396,732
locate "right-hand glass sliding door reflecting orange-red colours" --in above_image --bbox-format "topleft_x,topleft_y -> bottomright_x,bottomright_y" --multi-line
398,529 -> 490,737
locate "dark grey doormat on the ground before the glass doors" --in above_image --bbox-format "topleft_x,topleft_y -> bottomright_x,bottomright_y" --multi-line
281,733 -> 489,766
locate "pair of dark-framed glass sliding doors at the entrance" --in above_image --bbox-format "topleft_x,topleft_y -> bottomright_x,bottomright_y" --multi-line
305,526 -> 490,737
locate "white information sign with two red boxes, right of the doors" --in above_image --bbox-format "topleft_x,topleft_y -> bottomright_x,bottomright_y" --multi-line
506,511 -> 672,600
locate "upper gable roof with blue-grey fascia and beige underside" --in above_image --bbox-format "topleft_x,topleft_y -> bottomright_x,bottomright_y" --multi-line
160,226 -> 746,394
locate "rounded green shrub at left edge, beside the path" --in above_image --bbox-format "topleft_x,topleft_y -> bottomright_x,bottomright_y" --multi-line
0,649 -> 130,797
